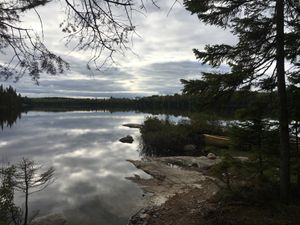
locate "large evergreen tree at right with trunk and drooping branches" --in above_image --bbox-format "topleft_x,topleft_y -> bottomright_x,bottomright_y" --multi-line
183,0 -> 300,202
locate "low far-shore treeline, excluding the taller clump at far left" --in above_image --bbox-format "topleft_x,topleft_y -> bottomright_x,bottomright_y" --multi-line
22,91 -> 284,118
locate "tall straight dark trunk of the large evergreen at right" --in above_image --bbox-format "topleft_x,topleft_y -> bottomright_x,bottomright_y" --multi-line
276,0 -> 290,203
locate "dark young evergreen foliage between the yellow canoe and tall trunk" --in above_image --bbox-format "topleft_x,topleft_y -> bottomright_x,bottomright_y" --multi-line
230,119 -> 279,182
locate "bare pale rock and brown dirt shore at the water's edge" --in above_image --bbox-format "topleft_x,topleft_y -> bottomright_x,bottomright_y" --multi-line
127,156 -> 223,225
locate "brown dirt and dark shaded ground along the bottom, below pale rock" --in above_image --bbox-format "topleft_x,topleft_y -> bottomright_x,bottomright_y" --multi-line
129,189 -> 300,225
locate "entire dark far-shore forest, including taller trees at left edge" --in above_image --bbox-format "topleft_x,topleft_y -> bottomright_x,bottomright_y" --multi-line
0,85 -> 300,119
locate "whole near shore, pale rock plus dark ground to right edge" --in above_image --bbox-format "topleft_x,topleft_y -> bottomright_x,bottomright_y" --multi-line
127,156 -> 300,225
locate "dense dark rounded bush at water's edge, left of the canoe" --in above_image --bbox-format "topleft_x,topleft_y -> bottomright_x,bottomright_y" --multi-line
140,117 -> 201,156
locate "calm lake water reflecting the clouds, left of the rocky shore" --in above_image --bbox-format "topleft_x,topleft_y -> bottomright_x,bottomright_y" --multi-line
0,112 -> 178,225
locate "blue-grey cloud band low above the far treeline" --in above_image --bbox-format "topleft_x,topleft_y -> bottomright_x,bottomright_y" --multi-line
2,60 -> 228,98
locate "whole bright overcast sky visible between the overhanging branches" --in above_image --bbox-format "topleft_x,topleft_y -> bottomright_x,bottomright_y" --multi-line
0,0 -> 235,98
